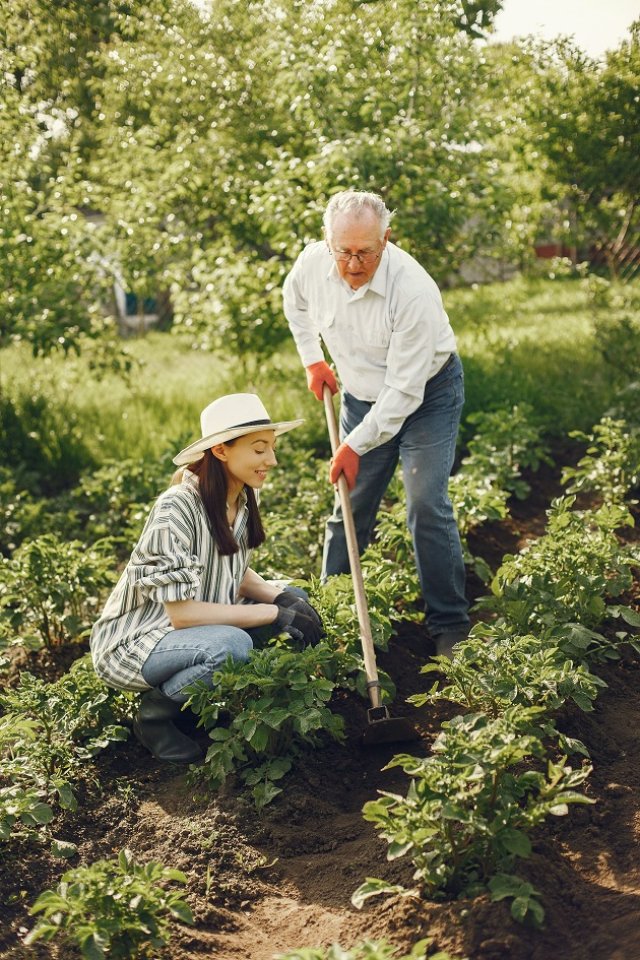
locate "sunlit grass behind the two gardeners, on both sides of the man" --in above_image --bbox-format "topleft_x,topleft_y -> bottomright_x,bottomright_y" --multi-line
0,278 -> 636,484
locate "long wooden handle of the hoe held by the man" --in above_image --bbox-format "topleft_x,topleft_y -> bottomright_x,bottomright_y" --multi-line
322,383 -> 381,707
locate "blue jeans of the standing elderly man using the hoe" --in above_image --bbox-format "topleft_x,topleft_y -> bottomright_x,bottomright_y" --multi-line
322,355 -> 469,636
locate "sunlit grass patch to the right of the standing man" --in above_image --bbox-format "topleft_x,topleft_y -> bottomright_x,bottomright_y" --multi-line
446,277 -> 614,435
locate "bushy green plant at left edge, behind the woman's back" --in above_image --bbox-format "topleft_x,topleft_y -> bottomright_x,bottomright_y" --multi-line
0,534 -> 114,649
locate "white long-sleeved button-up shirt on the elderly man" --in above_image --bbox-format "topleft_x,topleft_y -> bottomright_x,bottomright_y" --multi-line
283,241 -> 456,455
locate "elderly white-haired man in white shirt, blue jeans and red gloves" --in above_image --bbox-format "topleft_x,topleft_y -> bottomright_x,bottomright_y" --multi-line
284,190 -> 469,656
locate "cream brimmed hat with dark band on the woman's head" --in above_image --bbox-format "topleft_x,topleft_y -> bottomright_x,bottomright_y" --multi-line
173,393 -> 304,467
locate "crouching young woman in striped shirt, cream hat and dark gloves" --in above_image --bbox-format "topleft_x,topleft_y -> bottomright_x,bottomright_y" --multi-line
90,393 -> 322,763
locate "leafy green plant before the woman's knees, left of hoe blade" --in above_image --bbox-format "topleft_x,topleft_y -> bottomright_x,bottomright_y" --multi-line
187,643 -> 343,808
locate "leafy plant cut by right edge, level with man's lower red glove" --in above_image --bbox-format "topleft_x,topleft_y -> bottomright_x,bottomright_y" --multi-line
562,417 -> 640,503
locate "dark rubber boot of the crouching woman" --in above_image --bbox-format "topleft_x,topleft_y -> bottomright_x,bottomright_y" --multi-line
133,687 -> 202,763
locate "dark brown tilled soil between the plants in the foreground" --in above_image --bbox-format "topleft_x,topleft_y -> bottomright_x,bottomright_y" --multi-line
0,460 -> 640,960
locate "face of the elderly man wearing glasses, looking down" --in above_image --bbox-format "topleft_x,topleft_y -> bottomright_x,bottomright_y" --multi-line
329,210 -> 391,290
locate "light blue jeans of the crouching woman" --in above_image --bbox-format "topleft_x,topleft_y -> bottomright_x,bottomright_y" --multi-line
142,587 -> 308,703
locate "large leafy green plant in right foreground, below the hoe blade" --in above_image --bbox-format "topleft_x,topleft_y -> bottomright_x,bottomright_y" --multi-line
356,707 -> 590,897
